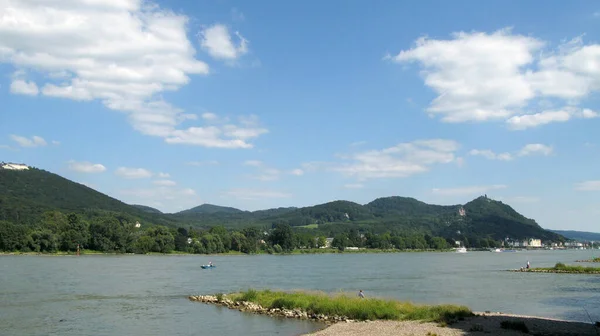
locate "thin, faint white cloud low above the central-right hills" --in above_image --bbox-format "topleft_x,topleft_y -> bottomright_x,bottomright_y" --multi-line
328,139 -> 459,180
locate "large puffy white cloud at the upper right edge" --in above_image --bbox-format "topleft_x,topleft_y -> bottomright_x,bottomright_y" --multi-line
386,29 -> 600,129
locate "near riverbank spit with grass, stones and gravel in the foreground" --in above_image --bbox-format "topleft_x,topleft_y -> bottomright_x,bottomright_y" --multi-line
189,290 -> 600,336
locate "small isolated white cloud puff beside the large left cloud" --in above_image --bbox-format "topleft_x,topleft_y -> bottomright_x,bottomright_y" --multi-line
200,24 -> 248,61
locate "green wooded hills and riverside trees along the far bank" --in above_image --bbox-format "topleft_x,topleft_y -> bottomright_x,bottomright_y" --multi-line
0,168 -> 564,253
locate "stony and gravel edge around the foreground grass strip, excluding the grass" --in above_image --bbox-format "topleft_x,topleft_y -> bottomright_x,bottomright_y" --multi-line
188,294 -> 600,336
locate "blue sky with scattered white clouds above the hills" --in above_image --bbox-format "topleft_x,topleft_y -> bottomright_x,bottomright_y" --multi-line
0,0 -> 600,232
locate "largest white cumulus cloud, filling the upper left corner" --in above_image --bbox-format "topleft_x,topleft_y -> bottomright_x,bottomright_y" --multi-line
0,0 -> 265,148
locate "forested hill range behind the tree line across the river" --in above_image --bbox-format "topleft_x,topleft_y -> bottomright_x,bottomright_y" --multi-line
0,168 -> 564,241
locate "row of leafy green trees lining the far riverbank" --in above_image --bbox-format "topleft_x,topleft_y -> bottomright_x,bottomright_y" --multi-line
0,211 -> 506,254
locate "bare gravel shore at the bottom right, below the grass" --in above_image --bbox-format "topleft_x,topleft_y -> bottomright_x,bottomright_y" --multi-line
307,313 -> 600,336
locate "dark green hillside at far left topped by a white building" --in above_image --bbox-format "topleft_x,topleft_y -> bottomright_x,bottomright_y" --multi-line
0,168 -> 172,224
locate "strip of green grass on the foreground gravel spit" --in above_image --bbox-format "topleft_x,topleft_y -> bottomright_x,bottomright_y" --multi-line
227,289 -> 473,322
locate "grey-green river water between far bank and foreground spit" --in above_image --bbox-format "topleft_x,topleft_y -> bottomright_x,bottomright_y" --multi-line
0,250 -> 600,336
